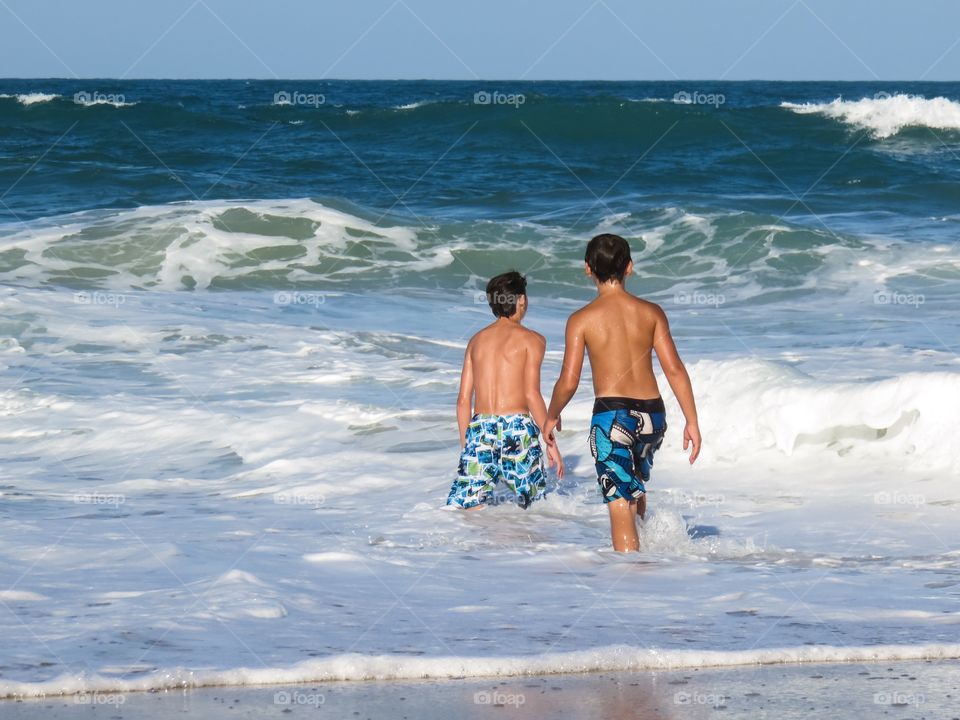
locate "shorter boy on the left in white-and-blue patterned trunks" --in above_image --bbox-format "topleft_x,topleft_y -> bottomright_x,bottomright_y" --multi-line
447,271 -> 563,509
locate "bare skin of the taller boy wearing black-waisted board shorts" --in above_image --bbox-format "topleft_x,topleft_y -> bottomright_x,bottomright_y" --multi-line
543,262 -> 700,552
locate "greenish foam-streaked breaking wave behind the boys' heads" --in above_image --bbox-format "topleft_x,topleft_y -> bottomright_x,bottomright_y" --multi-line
0,199 -> 960,305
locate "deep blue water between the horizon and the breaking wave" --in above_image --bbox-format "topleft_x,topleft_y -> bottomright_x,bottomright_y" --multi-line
0,80 -> 960,233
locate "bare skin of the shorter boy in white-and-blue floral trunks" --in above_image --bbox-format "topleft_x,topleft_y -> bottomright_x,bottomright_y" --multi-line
457,295 -> 563,507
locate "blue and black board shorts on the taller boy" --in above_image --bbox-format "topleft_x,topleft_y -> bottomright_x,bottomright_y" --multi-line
590,397 -> 667,503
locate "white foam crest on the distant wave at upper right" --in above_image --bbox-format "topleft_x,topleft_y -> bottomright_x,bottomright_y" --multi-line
781,94 -> 960,138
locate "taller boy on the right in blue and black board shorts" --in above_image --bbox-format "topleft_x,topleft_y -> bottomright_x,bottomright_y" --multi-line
543,233 -> 700,552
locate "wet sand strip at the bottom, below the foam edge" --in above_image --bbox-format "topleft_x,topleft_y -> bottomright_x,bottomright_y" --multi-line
3,660 -> 960,720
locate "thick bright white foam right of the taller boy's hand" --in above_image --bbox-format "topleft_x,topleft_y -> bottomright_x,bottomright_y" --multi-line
691,359 -> 960,470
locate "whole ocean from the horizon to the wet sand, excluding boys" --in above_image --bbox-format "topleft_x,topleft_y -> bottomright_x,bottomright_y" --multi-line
0,80 -> 960,696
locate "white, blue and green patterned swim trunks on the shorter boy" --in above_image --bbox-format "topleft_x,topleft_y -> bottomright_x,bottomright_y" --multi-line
447,413 -> 547,509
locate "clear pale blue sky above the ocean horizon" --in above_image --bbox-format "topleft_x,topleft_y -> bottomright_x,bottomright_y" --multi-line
0,0 -> 960,80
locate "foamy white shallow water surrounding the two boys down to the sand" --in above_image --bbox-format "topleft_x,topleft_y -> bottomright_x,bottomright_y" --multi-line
0,284 -> 960,695
